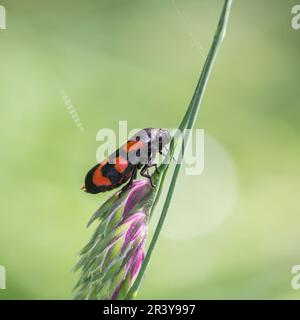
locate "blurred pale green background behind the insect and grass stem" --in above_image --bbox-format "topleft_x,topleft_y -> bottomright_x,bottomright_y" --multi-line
0,0 -> 300,299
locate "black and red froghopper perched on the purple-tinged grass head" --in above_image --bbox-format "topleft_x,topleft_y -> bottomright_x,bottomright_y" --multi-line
82,128 -> 171,194
